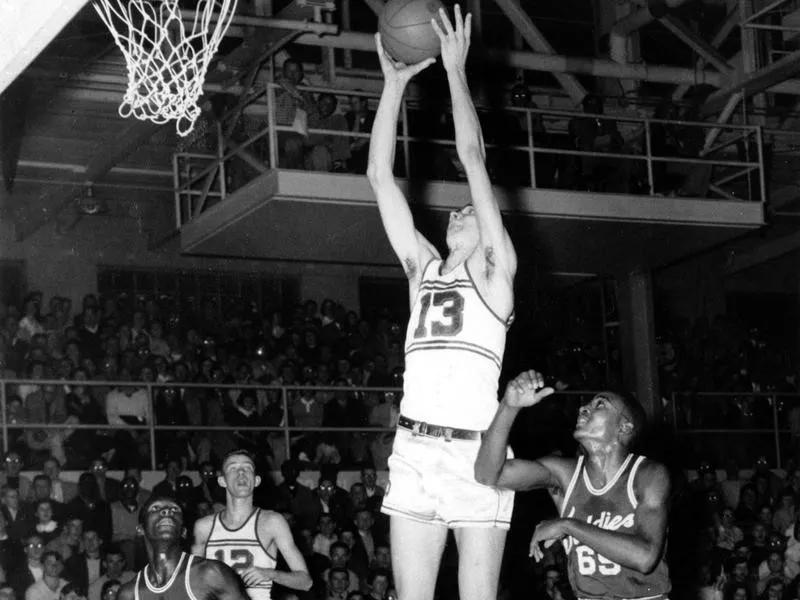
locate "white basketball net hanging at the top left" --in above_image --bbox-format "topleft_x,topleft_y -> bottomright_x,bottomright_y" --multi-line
94,0 -> 237,137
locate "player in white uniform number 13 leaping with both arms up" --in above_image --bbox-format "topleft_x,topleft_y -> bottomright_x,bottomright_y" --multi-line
368,6 -> 517,600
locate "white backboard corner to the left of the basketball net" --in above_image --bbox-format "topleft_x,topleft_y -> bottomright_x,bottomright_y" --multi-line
0,0 -> 87,92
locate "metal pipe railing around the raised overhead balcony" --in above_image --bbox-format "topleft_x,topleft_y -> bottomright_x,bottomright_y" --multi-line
174,84 -> 766,228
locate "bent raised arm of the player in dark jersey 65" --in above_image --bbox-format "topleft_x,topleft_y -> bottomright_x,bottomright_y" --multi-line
475,371 -> 575,490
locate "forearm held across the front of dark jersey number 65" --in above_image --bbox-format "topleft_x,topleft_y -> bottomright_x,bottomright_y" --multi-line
563,519 -> 662,573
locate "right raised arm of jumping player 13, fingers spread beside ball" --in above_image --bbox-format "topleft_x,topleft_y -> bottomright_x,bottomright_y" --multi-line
431,4 -> 517,279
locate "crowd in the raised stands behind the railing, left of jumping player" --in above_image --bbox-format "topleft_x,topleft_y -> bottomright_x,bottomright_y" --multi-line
0,292 -> 403,476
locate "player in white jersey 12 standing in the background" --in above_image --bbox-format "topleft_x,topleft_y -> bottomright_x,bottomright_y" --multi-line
192,450 -> 312,600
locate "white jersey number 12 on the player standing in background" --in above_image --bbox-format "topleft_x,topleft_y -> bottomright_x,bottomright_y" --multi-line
205,508 -> 277,600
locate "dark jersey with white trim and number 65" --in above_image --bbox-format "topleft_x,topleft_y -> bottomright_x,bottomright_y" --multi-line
561,454 -> 670,600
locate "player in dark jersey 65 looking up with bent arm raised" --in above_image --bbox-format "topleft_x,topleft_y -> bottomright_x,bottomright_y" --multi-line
475,371 -> 670,600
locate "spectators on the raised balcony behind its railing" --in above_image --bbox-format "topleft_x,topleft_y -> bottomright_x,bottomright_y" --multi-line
260,58 -> 711,197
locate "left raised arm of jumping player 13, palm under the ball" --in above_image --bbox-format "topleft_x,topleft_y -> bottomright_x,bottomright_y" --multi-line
367,34 -> 436,279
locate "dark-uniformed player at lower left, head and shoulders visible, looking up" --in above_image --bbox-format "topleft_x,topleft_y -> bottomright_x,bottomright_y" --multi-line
117,497 -> 247,600
